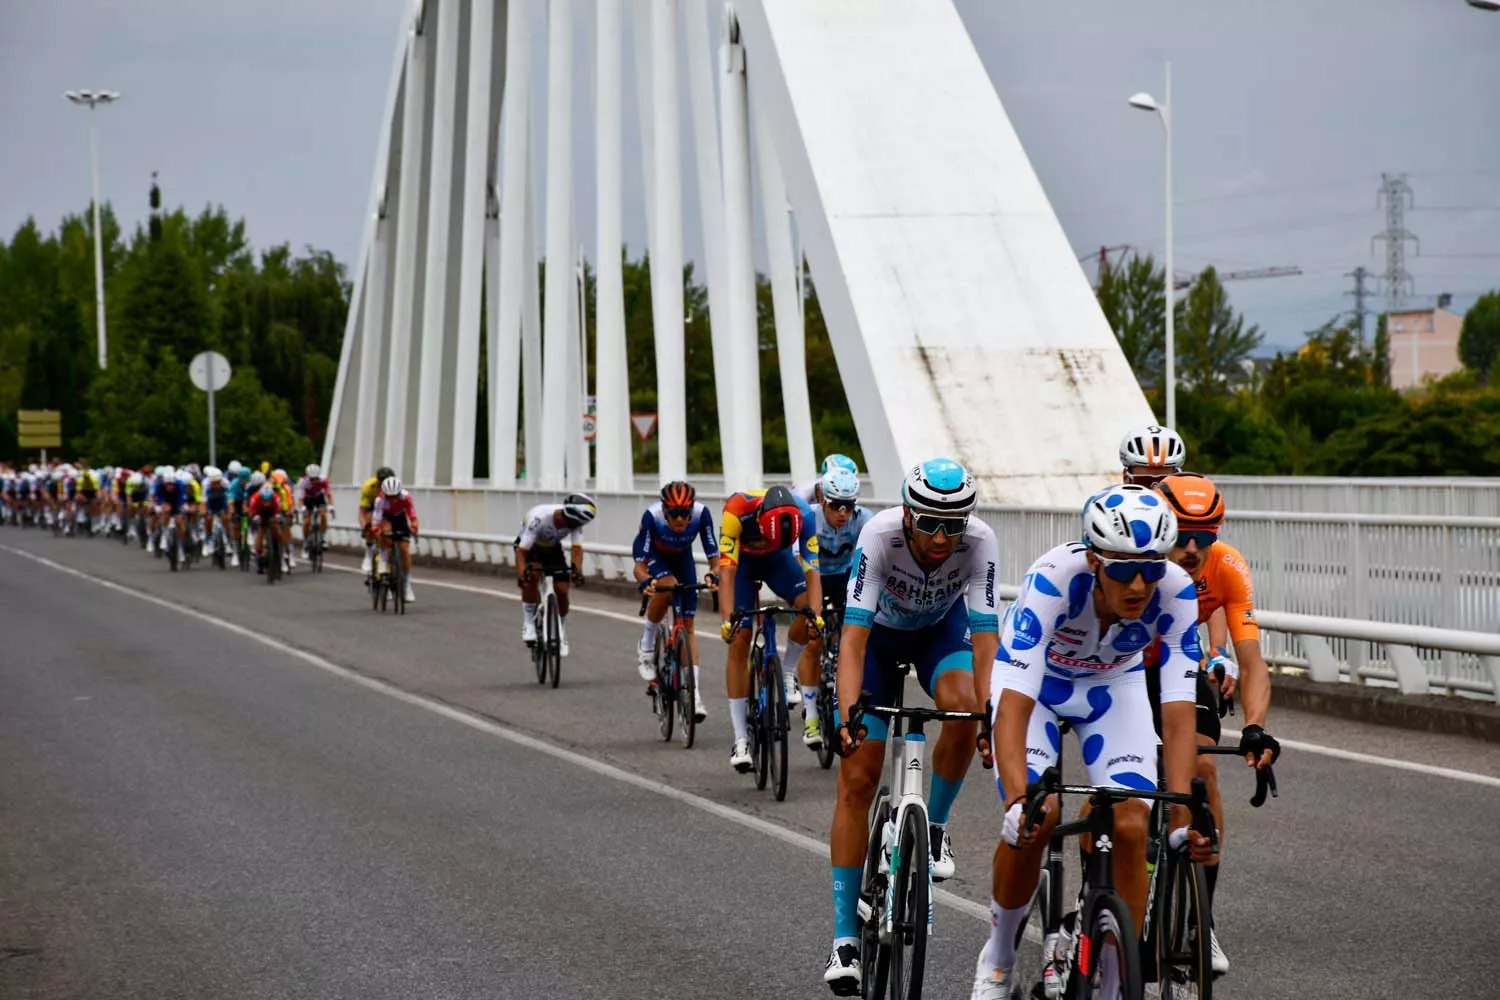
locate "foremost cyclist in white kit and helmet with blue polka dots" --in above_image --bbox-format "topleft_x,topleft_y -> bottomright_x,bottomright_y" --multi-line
972,484 -> 1211,1000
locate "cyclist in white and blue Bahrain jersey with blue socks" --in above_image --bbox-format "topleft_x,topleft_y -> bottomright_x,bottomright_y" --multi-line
824,459 -> 999,996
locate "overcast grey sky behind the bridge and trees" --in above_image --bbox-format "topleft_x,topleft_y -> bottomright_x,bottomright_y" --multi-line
0,0 -> 1500,353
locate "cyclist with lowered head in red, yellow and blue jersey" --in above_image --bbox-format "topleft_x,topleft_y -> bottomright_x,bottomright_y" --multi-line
719,486 -> 824,774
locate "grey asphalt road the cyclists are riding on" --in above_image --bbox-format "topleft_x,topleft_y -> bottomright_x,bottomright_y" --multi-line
0,529 -> 1500,1000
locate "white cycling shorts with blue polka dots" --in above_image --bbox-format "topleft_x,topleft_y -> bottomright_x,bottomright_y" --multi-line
992,664 -> 1157,808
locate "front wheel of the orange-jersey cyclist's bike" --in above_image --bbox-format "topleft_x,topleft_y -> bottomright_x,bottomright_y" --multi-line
1152,849 -> 1214,1000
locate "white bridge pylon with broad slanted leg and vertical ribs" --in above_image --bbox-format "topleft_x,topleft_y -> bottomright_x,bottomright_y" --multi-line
324,0 -> 1151,504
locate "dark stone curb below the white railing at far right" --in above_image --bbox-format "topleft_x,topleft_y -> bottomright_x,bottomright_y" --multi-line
1271,673 -> 1500,744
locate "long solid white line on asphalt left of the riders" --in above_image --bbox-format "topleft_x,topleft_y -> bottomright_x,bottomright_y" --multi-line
0,546 -> 990,922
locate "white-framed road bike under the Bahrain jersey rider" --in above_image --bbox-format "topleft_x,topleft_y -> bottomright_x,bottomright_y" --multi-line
852,663 -> 986,1000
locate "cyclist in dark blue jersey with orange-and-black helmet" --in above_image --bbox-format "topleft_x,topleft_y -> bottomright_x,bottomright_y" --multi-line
632,481 -> 719,723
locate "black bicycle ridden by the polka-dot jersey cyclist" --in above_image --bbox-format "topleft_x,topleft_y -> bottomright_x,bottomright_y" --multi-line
1017,766 -> 1218,1000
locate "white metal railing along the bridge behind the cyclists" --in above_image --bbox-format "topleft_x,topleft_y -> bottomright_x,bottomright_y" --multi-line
335,487 -> 1500,696
